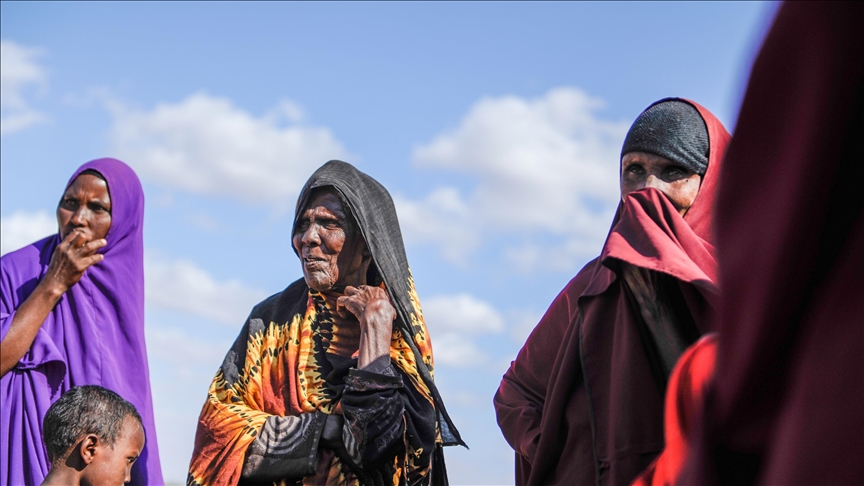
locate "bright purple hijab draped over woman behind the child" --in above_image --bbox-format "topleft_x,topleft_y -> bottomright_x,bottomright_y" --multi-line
0,159 -> 164,486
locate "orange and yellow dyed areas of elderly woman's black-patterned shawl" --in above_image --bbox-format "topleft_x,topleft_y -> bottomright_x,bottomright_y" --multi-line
188,279 -> 441,486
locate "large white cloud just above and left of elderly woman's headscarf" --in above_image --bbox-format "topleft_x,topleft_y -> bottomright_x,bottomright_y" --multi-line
108,92 -> 356,207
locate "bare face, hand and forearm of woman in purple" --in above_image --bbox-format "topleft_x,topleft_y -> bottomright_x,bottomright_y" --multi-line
0,174 -> 111,376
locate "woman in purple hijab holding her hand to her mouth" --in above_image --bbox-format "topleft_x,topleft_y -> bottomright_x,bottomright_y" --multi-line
0,159 -> 163,486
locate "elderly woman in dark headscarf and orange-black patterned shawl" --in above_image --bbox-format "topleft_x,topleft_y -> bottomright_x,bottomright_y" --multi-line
188,160 -> 462,485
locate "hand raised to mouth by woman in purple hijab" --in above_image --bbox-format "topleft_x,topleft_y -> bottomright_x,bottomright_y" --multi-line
43,230 -> 107,293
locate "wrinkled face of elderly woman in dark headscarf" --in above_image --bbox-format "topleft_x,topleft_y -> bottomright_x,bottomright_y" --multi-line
292,188 -> 372,291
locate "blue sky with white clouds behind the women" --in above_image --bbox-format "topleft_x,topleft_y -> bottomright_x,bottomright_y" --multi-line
0,2 -> 776,484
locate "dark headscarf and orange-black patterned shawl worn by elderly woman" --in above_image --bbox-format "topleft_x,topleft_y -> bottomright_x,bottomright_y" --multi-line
188,161 -> 463,485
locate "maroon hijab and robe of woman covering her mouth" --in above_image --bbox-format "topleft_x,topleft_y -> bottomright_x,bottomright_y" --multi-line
495,100 -> 729,485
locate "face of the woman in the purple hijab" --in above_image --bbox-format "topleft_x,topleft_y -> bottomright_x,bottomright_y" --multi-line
57,174 -> 111,241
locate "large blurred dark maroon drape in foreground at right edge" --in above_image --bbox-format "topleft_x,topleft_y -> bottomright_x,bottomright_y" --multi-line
680,2 -> 864,485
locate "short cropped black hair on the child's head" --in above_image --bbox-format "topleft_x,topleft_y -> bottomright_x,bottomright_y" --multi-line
42,385 -> 141,464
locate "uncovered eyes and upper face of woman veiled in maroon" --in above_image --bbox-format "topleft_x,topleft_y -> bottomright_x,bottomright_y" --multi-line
621,152 -> 702,216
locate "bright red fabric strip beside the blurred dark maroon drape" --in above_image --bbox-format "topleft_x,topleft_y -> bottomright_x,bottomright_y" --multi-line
633,333 -> 717,486
